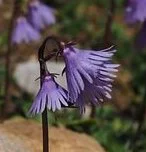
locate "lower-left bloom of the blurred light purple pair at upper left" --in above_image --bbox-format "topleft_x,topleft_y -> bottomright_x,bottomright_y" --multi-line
12,16 -> 40,44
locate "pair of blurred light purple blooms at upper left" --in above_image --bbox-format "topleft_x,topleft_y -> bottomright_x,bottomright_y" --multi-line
11,0 -> 55,44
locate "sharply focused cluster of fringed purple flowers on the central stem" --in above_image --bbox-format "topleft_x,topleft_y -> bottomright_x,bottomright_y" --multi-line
30,44 -> 119,114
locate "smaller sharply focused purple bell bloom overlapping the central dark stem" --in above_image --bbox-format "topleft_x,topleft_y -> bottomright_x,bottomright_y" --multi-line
29,75 -> 68,115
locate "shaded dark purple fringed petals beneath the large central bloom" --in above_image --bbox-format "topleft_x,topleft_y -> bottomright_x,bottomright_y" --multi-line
75,76 -> 112,113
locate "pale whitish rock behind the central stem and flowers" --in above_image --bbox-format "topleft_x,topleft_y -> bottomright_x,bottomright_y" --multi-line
14,58 -> 67,95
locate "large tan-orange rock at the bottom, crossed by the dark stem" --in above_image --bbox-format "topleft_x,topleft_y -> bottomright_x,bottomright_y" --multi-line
0,118 -> 105,152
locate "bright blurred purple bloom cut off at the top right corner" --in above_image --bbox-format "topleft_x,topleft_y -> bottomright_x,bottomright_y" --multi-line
125,0 -> 146,24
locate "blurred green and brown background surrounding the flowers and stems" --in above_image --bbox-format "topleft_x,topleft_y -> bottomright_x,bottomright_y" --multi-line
0,0 -> 146,152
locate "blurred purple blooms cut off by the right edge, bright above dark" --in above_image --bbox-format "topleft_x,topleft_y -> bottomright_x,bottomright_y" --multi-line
125,0 -> 146,48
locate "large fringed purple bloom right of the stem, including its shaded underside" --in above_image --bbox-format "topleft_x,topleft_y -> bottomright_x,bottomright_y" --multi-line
63,46 -> 119,112
